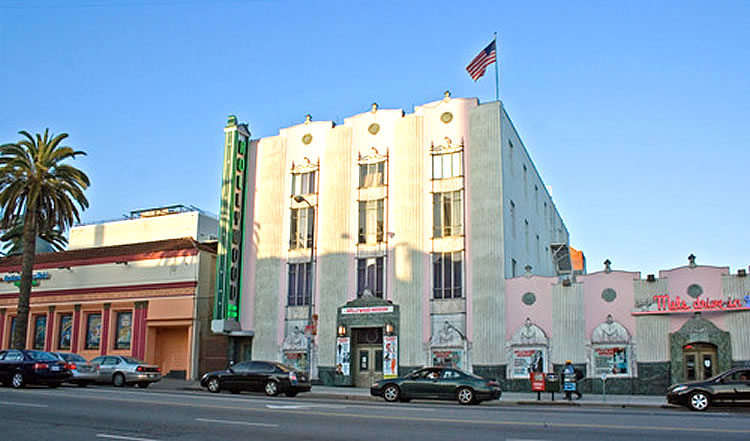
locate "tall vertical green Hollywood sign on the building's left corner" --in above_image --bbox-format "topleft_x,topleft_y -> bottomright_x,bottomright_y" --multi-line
214,115 -> 250,321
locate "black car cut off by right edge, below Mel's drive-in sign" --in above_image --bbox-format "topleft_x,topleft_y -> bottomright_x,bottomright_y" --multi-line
667,368 -> 750,411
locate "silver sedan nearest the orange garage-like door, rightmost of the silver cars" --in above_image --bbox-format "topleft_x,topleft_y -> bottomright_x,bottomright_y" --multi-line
91,355 -> 161,388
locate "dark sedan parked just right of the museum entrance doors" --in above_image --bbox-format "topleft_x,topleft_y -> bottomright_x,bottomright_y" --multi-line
370,367 -> 502,404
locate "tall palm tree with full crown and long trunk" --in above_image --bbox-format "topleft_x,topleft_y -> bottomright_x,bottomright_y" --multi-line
0,129 -> 89,349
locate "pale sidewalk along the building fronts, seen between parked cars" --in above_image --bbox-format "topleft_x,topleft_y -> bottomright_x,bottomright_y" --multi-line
151,378 -> 668,408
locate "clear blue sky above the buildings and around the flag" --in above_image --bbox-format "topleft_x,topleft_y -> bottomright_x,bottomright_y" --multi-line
0,0 -> 750,277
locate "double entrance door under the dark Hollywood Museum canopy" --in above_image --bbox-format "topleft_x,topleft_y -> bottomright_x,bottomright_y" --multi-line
352,328 -> 383,387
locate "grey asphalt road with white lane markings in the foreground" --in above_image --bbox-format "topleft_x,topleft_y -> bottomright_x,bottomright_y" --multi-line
0,386 -> 750,441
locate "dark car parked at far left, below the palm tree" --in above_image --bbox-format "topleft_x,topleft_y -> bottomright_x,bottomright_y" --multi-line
0,349 -> 72,389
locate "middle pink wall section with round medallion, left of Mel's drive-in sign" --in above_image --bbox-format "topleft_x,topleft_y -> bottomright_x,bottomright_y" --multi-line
576,271 -> 641,339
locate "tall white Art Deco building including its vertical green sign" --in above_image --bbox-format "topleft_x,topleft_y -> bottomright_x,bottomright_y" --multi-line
212,93 -> 570,386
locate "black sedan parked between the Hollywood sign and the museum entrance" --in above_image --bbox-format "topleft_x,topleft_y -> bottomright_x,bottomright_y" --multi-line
201,361 -> 310,397
